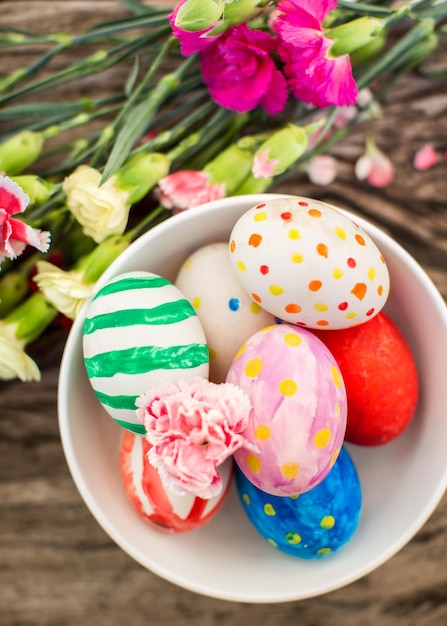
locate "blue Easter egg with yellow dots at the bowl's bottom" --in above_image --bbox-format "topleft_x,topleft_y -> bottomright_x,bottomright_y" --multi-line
235,448 -> 362,559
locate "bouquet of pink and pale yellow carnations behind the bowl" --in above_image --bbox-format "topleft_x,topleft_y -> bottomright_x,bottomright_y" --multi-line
0,0 -> 447,381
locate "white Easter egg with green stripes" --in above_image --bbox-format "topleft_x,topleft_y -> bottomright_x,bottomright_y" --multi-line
83,271 -> 209,434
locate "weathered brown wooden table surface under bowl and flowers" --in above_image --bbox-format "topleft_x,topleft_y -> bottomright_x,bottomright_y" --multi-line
0,0 -> 447,626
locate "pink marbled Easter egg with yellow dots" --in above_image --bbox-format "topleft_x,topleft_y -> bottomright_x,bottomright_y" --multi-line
227,324 -> 346,496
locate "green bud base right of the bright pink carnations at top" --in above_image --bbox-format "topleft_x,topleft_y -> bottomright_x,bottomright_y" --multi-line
325,16 -> 383,57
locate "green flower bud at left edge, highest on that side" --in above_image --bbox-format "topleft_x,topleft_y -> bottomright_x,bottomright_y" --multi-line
0,130 -> 45,176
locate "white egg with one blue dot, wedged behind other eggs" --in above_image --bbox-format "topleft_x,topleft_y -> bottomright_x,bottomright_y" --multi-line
175,242 -> 275,383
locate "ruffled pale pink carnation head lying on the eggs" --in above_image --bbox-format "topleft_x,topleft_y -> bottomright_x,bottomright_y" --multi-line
137,379 -> 253,498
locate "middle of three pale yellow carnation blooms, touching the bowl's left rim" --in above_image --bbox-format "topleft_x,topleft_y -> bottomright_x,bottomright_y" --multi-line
34,261 -> 94,319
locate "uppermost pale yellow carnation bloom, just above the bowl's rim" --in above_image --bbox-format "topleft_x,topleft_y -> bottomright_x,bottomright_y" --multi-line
62,165 -> 130,243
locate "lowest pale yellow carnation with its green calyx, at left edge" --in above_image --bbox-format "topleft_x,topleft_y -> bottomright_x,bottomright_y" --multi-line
0,291 -> 58,382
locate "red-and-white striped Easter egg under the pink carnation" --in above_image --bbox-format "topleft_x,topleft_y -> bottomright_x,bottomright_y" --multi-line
119,430 -> 233,533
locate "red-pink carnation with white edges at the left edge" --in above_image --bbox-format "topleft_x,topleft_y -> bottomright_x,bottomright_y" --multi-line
0,175 -> 50,263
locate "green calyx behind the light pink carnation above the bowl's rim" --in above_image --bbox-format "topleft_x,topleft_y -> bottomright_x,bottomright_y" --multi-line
203,144 -> 253,196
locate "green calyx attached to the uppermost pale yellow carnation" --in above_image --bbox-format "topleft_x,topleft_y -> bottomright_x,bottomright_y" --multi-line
115,153 -> 170,204
